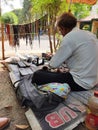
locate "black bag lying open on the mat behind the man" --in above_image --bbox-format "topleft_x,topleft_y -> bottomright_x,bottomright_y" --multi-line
16,75 -> 64,111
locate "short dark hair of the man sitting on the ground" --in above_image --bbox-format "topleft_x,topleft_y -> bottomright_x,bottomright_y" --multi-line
57,12 -> 77,29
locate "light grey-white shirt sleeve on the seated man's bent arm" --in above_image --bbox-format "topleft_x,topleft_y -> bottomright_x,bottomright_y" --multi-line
49,40 -> 72,68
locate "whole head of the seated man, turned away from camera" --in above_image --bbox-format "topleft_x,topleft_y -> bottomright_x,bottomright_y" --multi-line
57,12 -> 77,36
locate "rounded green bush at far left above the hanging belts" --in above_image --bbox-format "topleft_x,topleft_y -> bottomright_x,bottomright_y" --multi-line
1,12 -> 18,24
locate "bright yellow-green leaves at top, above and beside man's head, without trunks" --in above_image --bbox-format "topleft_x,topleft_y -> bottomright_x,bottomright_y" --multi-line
31,0 -> 91,19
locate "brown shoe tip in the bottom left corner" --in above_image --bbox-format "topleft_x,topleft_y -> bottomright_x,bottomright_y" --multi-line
0,117 -> 10,130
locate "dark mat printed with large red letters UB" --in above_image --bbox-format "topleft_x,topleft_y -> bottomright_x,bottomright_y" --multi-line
31,95 -> 86,130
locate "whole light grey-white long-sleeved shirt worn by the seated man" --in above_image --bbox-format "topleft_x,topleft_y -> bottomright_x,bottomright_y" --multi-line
50,27 -> 98,89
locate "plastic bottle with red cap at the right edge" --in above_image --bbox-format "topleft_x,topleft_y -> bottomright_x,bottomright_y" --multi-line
85,91 -> 98,130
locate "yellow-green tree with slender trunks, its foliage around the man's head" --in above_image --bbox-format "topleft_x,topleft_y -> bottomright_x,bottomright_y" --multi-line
31,0 -> 91,52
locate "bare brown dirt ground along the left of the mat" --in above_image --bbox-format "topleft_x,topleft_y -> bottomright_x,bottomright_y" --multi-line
0,63 -> 31,130
